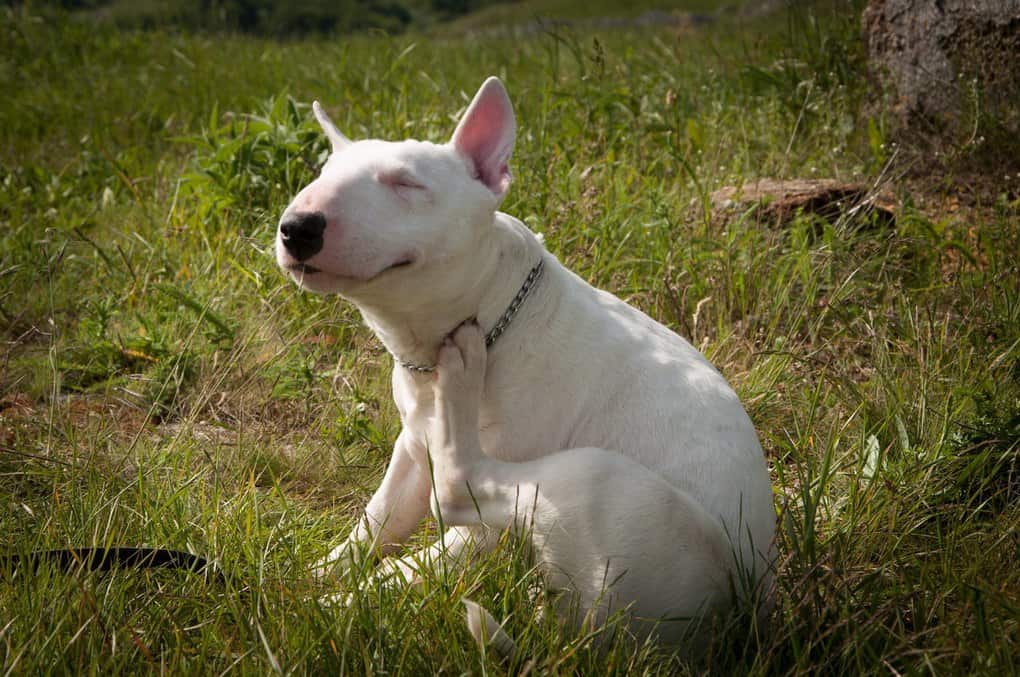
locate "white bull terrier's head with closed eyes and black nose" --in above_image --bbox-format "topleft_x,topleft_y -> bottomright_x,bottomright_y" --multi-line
276,77 -> 516,300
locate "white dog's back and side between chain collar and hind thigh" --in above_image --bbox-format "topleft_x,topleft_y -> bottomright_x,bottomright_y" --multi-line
467,215 -> 775,573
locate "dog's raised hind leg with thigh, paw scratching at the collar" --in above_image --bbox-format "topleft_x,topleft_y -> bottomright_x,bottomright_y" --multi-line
428,324 -> 734,642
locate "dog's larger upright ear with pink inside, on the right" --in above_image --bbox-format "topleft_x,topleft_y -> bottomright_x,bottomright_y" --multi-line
450,77 -> 517,200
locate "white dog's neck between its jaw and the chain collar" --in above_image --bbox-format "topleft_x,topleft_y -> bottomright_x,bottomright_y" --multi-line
354,213 -> 543,371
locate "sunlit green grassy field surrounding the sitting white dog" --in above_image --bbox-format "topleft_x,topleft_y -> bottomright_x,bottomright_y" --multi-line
0,4 -> 1020,674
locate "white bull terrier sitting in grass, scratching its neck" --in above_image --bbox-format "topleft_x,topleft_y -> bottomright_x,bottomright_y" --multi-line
276,77 -> 775,652
